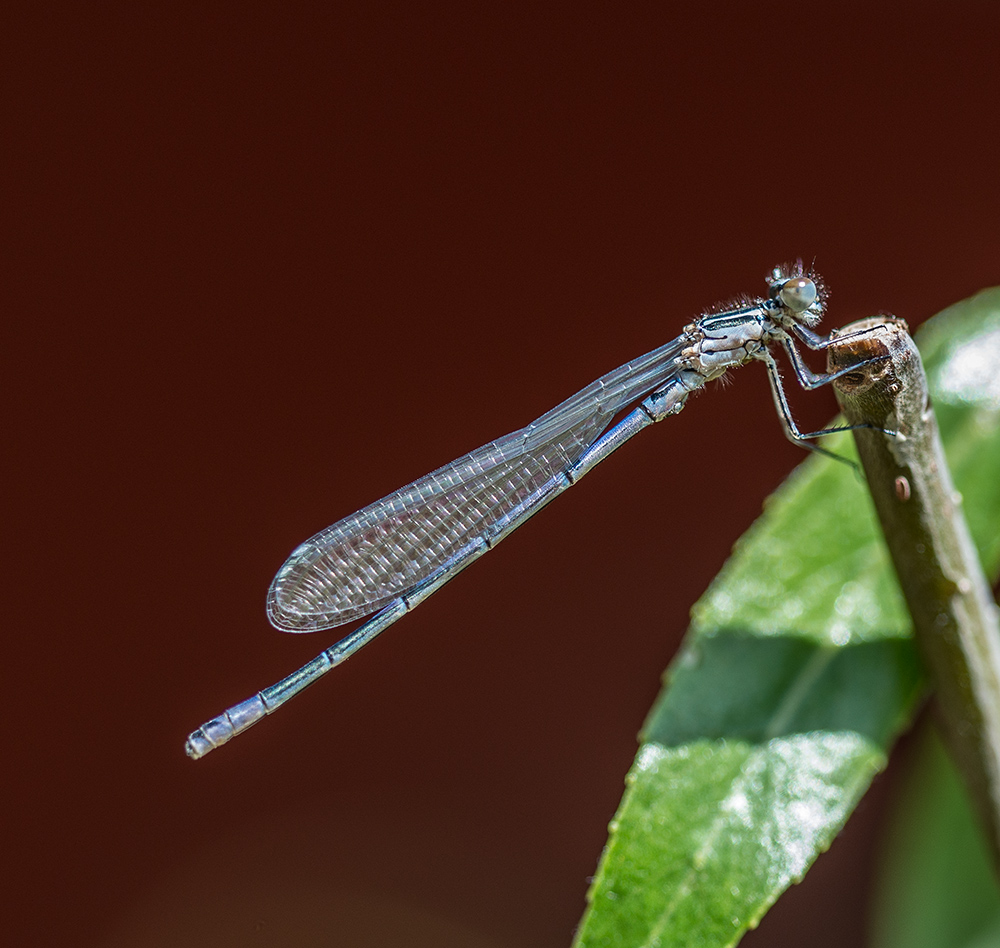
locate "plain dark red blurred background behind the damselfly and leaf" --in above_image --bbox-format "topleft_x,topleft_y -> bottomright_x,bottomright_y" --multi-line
3,3 -> 1000,948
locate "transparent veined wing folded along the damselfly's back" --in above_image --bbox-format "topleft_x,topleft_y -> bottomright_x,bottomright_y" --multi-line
267,336 -> 686,632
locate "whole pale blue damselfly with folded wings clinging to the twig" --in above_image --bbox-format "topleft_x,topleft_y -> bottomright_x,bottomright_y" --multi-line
187,262 -> 884,758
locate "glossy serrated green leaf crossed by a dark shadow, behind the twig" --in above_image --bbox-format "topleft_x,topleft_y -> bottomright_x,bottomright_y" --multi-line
575,289 -> 1000,948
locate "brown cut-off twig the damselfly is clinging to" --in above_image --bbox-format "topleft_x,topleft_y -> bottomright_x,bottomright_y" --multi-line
828,317 -> 1000,872
